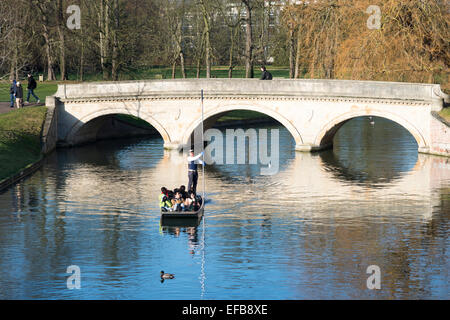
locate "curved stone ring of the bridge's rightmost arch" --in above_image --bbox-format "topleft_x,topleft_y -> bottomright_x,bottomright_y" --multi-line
314,110 -> 430,151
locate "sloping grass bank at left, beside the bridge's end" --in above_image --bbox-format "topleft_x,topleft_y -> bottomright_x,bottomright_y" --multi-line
0,107 -> 46,180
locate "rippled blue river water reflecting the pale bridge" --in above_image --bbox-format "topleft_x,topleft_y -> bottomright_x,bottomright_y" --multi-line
0,118 -> 450,299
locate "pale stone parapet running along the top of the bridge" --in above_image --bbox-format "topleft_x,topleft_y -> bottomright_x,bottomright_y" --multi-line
55,79 -> 445,111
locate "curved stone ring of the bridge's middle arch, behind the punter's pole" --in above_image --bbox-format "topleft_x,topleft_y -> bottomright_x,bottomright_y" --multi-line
182,103 -> 303,145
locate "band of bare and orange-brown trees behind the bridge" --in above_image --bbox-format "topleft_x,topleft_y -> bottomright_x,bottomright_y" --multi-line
0,0 -> 450,88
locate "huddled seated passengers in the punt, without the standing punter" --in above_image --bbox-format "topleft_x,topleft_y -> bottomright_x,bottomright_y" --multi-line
159,186 -> 202,212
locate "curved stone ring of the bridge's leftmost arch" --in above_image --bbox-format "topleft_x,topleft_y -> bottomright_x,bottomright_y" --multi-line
65,107 -> 171,144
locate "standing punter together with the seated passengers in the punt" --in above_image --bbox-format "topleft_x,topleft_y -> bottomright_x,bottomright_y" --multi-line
159,149 -> 205,212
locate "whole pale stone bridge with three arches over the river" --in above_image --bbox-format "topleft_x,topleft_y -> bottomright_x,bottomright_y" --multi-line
46,79 -> 450,156
